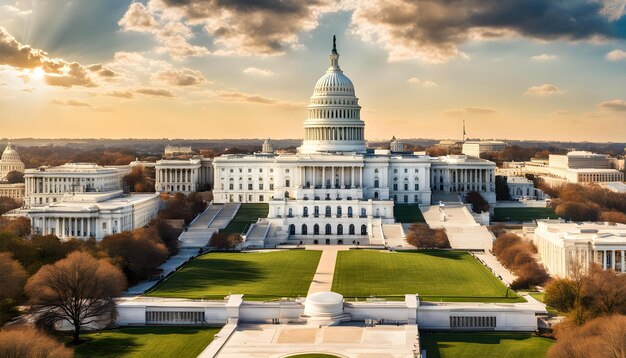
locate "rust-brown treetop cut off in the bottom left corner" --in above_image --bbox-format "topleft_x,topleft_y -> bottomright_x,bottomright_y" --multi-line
0,327 -> 74,358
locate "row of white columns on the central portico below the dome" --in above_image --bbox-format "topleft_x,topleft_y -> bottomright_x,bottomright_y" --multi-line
299,166 -> 363,189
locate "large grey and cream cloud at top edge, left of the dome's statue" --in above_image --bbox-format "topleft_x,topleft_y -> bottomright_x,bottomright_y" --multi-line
133,0 -> 337,56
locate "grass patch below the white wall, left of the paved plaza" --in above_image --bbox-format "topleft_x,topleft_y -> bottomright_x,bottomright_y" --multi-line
75,327 -> 220,358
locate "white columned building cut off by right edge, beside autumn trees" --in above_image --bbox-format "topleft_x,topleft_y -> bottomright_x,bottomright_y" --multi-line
533,220 -> 626,277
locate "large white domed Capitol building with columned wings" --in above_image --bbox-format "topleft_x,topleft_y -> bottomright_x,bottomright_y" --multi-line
156,40 -> 496,243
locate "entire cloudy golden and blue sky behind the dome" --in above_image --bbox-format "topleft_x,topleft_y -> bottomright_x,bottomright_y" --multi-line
0,0 -> 626,141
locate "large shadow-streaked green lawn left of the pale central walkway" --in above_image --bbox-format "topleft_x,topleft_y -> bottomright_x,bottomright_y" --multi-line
147,250 -> 321,300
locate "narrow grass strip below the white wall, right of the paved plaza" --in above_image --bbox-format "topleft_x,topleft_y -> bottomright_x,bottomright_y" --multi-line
420,332 -> 555,358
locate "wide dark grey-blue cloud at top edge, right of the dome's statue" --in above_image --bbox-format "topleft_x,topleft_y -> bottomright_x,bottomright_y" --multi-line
350,0 -> 626,63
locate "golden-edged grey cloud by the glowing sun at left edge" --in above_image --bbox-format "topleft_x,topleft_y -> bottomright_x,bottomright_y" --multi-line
0,27 -> 96,88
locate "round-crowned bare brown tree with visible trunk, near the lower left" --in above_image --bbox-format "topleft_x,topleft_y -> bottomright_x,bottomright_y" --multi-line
26,252 -> 126,343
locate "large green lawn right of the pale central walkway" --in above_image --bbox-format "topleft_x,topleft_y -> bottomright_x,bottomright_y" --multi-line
332,250 -> 524,302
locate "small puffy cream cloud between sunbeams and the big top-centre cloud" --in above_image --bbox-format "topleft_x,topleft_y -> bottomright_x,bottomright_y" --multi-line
118,2 -> 209,59
